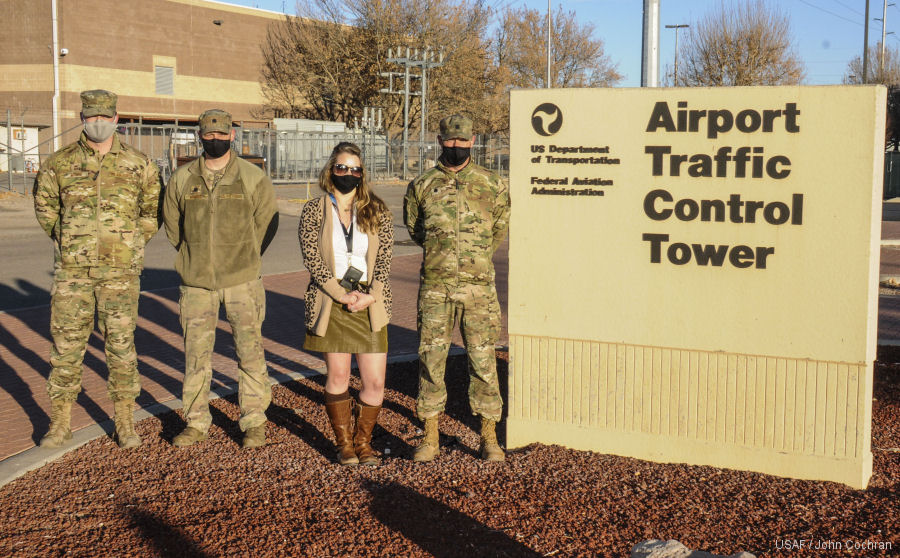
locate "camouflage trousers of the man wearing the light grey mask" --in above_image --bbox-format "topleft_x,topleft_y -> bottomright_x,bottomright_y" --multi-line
47,267 -> 141,401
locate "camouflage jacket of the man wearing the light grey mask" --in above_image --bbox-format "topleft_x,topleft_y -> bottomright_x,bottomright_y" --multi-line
34,132 -> 160,273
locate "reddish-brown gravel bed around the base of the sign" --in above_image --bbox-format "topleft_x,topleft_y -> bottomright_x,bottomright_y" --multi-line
0,354 -> 900,557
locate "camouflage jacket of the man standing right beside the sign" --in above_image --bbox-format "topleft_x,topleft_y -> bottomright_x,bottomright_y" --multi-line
403,162 -> 510,288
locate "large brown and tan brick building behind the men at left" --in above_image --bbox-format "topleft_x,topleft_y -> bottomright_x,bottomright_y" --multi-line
0,0 -> 284,153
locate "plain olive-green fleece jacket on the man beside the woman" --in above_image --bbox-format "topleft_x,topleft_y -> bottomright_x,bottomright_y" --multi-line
163,150 -> 278,290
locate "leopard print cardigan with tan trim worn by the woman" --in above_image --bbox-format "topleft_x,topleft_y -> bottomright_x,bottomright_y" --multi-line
298,195 -> 394,335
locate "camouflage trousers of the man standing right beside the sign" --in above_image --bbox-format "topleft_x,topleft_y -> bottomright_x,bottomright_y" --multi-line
416,284 -> 503,420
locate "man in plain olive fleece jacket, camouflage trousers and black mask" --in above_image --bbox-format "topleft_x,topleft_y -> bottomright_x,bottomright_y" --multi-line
163,109 -> 278,448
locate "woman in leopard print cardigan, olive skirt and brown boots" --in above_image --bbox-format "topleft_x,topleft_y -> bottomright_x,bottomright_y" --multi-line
299,142 -> 394,465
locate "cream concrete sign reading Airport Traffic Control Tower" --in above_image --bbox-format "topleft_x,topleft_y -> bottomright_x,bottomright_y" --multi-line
507,86 -> 885,487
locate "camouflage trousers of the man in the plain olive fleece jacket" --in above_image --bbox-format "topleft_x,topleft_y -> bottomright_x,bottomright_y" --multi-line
179,279 -> 272,432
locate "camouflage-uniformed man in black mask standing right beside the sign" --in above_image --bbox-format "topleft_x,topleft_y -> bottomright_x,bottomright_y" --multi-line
403,114 -> 510,461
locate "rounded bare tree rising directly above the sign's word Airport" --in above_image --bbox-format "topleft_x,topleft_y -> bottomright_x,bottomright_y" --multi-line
678,0 -> 804,86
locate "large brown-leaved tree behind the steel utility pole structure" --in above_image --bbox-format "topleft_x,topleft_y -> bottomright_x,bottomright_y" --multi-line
262,0 -> 490,134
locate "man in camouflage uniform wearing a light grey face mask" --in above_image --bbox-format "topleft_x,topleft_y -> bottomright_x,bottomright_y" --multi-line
34,90 -> 160,448
